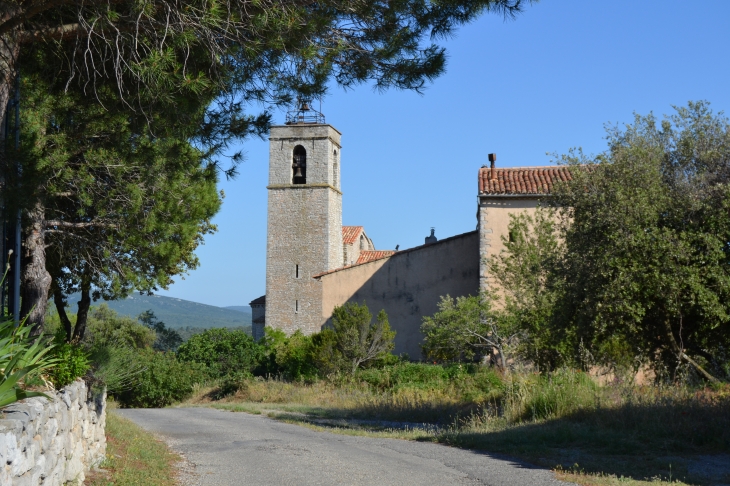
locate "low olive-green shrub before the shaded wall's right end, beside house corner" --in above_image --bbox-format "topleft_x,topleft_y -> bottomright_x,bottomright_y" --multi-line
421,295 -> 520,369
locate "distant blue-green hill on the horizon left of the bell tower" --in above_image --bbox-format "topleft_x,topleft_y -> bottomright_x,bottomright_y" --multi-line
68,294 -> 251,328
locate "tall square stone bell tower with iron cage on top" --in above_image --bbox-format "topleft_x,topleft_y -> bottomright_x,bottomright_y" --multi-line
262,102 -> 343,334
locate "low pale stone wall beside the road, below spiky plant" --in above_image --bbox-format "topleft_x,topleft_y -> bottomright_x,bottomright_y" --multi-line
0,381 -> 106,486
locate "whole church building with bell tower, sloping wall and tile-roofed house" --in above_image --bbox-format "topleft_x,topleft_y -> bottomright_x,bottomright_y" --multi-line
251,103 -> 570,359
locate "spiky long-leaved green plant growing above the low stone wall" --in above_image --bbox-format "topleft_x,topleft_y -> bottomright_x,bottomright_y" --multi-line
0,320 -> 57,408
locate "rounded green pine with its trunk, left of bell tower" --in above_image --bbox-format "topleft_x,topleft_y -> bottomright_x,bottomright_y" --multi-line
12,55 -> 221,339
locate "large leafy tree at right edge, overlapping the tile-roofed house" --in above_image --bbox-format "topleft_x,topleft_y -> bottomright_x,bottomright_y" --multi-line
554,102 -> 730,380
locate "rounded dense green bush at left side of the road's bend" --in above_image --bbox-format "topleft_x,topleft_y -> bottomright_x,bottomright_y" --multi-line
115,349 -> 206,408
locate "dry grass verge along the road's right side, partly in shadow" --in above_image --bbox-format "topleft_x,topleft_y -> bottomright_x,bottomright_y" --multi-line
186,370 -> 730,485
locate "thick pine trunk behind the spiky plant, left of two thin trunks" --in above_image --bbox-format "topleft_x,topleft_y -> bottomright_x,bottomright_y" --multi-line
20,202 -> 51,335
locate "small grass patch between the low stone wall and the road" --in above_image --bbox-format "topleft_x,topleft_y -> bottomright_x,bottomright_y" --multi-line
85,402 -> 180,486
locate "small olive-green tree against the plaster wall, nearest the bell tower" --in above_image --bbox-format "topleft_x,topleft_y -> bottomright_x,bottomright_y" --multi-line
332,302 -> 395,373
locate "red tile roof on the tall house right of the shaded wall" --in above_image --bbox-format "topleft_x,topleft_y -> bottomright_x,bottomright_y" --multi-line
479,166 -> 573,195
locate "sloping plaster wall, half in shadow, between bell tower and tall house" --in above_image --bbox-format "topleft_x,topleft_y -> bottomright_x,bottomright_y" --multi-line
314,231 -> 479,359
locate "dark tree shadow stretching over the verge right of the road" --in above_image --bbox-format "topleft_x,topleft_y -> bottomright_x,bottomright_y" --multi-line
268,397 -> 730,485
